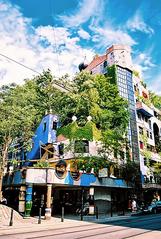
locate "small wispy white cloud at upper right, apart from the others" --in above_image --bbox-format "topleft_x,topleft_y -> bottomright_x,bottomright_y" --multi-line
127,13 -> 154,35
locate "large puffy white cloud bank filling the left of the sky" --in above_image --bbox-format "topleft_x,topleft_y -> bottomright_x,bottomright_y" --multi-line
0,1 -> 94,85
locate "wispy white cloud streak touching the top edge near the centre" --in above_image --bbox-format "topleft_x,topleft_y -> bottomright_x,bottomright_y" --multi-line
59,0 -> 104,27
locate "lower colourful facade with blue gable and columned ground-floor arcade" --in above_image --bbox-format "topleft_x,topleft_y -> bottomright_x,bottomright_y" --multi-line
3,113 -> 132,218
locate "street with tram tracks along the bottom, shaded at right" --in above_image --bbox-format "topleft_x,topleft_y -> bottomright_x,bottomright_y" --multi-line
0,214 -> 161,239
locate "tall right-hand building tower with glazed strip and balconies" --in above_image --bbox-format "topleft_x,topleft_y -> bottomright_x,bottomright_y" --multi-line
86,45 -> 161,202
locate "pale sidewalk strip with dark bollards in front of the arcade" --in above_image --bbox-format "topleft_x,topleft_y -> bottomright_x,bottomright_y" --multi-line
0,213 -> 141,235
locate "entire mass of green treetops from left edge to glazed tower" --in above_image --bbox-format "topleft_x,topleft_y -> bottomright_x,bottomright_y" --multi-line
0,66 -> 129,176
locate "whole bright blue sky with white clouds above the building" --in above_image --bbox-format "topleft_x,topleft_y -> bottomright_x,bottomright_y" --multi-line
0,0 -> 161,95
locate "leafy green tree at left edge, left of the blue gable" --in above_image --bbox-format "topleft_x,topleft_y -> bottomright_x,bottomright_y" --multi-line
0,70 -> 70,200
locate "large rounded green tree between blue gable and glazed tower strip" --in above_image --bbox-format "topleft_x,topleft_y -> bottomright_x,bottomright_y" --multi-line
59,72 -> 129,173
